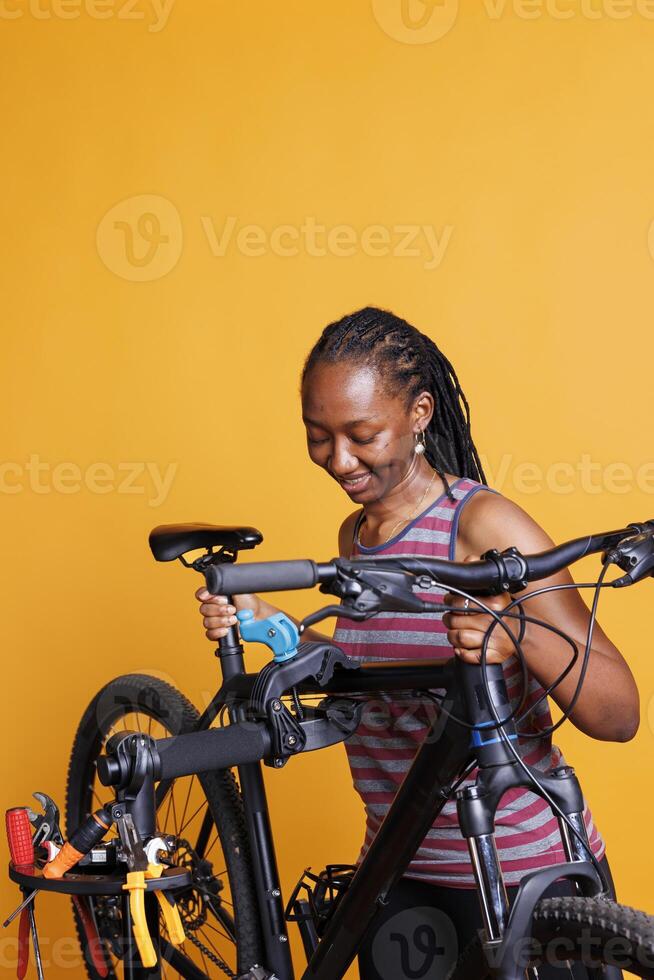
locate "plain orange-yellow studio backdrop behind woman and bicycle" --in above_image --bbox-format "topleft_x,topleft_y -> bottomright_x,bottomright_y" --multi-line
0,0 -> 654,980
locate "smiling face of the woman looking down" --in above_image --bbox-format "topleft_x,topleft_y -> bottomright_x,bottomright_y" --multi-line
302,362 -> 433,504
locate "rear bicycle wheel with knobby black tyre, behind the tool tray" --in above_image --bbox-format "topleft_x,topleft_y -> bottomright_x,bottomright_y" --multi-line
66,674 -> 262,980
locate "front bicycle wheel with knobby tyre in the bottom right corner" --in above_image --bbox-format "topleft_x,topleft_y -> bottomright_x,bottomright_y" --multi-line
448,897 -> 654,980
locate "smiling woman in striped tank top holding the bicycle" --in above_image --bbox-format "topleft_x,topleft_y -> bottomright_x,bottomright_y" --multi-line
196,308 -> 639,980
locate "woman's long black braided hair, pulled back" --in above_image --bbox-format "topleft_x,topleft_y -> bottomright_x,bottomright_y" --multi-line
302,306 -> 486,500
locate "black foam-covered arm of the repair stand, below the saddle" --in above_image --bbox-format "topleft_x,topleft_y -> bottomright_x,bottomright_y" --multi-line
156,721 -> 270,779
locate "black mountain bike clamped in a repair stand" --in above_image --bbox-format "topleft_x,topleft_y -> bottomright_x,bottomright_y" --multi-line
57,521 -> 654,980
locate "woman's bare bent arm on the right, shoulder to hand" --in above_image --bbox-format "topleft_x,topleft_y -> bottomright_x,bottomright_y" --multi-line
444,492 -> 640,742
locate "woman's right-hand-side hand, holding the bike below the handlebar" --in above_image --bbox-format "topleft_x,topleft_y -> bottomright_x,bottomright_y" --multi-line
443,555 -> 517,664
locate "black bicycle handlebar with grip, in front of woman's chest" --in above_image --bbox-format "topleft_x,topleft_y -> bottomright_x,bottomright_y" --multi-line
204,520 -> 654,598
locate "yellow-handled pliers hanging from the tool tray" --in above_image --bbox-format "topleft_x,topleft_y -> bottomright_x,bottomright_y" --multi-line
116,813 -> 186,968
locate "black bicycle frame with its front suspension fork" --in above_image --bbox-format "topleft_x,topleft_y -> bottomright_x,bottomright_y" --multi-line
152,612 -> 601,980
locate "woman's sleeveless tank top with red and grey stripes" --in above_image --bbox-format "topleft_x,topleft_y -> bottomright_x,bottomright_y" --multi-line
334,478 -> 605,888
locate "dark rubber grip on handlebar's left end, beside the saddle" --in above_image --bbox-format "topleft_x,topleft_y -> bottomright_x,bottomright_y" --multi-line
204,559 -> 319,595
